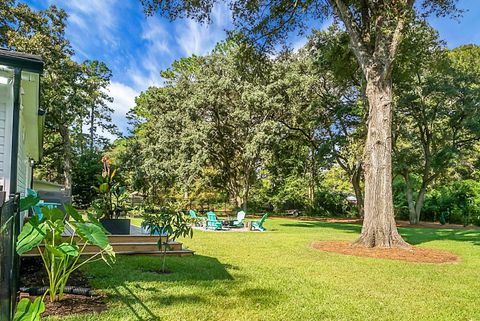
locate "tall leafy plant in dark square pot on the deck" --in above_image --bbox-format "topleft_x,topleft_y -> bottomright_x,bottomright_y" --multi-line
93,156 -> 130,235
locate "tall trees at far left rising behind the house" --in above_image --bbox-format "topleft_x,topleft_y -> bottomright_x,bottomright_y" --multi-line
0,0 -> 117,200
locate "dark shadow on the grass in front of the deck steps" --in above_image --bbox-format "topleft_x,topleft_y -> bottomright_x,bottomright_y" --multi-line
89,255 -> 234,321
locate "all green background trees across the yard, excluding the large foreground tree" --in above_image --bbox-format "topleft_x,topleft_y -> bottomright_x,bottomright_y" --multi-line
0,0 -> 480,229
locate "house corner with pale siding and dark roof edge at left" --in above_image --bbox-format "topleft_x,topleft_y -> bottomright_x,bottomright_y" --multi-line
0,49 -> 43,195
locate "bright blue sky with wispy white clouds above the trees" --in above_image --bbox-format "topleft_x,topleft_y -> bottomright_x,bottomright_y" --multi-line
24,0 -> 480,133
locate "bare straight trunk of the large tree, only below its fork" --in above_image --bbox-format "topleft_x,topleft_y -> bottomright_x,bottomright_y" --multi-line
354,77 -> 409,248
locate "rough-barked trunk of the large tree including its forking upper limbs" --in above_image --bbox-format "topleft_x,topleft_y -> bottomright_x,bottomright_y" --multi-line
329,0 -> 413,248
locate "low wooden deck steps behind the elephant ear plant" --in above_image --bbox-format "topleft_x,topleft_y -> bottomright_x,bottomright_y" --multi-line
22,235 -> 194,256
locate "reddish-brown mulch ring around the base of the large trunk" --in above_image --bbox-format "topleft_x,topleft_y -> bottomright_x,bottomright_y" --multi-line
312,241 -> 460,264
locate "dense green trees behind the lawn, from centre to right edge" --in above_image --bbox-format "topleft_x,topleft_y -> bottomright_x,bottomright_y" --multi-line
111,20 -> 480,223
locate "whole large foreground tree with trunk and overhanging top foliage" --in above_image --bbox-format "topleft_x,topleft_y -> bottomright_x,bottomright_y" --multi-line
141,0 -> 457,247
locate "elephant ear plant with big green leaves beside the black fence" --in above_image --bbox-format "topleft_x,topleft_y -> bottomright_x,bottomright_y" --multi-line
15,201 -> 115,320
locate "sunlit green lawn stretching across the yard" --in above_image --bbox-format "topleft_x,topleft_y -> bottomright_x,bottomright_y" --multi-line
46,219 -> 480,321
